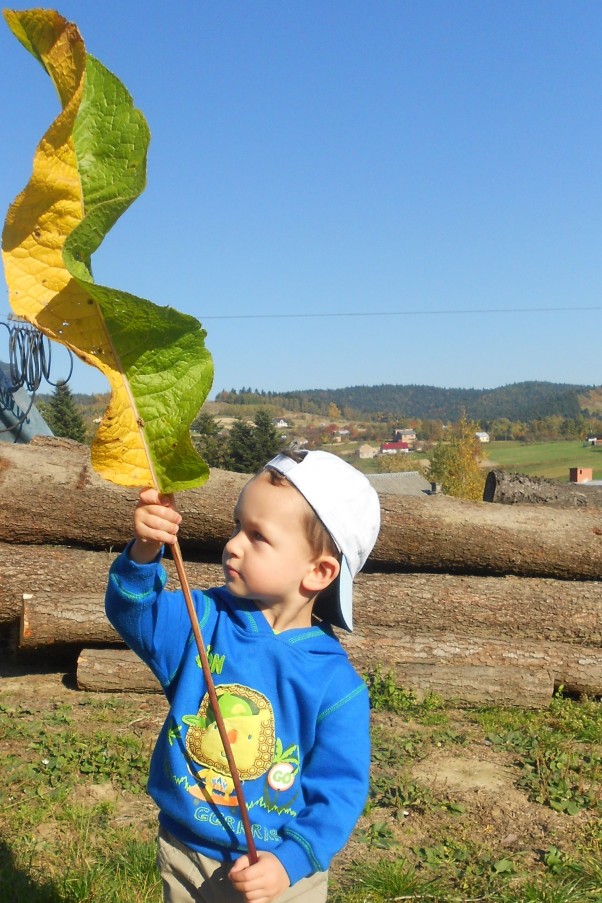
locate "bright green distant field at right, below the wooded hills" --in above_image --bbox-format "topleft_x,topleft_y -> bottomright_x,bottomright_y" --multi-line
483,441 -> 602,482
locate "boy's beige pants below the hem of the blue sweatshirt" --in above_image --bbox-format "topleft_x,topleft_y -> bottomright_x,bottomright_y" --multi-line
157,828 -> 328,903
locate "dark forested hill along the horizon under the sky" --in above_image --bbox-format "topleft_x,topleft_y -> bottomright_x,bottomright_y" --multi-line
216,381 -> 602,422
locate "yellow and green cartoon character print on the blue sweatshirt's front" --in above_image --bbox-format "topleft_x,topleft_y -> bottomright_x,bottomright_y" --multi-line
182,684 -> 299,808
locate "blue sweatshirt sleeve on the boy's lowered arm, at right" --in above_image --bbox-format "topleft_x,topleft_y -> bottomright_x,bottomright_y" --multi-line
274,678 -> 370,884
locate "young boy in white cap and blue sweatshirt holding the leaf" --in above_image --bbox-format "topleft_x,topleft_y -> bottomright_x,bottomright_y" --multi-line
106,451 -> 380,903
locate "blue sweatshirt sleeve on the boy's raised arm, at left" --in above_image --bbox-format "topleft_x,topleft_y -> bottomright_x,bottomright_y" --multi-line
105,545 -> 207,689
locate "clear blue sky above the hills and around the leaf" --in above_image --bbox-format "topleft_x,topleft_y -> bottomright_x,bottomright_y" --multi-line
0,0 -> 602,394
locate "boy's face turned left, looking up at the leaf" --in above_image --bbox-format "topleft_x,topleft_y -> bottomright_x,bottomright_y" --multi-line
222,473 -> 315,606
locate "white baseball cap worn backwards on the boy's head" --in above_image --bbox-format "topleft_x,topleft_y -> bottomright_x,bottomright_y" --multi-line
266,451 -> 380,630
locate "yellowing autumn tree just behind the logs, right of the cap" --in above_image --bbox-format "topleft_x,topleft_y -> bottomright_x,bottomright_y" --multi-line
428,412 -> 486,501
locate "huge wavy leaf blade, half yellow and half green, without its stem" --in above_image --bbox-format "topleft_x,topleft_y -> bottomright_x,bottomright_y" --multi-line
2,9 -> 213,492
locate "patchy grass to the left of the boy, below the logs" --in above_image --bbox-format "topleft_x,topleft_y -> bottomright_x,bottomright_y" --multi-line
0,694 -> 161,903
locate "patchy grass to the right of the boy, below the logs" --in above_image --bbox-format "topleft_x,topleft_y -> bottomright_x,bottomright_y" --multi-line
342,680 -> 602,903
